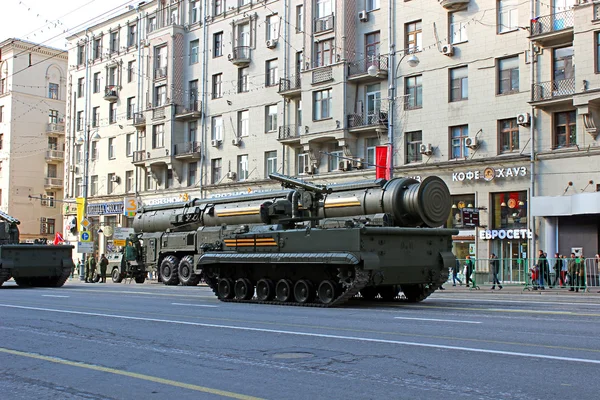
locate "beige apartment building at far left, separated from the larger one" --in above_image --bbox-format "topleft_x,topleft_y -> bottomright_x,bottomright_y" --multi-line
0,39 -> 67,242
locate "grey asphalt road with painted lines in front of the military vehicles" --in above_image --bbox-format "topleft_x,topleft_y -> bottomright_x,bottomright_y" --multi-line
0,282 -> 600,400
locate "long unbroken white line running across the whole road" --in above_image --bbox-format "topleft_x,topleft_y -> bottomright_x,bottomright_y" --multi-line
0,304 -> 600,365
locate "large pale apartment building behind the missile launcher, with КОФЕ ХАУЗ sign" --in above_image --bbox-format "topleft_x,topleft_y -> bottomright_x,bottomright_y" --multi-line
63,0 -> 600,268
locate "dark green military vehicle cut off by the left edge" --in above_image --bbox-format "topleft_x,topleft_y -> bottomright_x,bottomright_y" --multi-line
0,211 -> 75,287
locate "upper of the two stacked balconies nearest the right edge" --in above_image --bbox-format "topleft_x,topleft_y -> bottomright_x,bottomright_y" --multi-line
530,10 -> 575,46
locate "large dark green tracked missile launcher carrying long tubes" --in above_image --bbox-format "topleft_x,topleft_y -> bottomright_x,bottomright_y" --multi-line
133,174 -> 458,307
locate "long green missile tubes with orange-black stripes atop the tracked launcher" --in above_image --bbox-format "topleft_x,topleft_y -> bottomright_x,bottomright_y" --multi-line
133,177 -> 451,232
